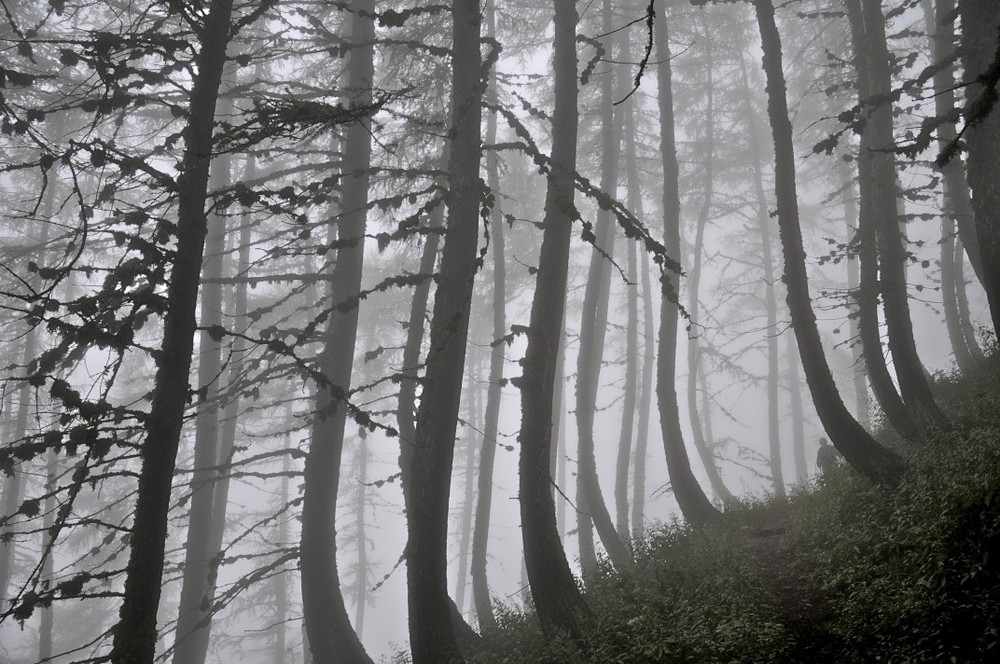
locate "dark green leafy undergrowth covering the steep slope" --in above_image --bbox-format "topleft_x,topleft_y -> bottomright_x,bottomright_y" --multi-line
398,352 -> 1000,664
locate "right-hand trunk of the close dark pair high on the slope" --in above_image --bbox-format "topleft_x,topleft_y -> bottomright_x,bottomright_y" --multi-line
844,0 -> 948,436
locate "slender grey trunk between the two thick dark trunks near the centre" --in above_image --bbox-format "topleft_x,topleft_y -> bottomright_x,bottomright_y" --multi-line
471,0 -> 507,631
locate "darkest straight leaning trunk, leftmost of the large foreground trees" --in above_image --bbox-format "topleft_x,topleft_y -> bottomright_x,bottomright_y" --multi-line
110,0 -> 233,664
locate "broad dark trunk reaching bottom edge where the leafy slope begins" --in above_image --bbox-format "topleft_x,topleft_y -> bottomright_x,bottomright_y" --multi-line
406,0 -> 483,664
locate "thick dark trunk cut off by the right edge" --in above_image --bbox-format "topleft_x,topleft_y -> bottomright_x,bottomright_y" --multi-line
958,0 -> 1000,335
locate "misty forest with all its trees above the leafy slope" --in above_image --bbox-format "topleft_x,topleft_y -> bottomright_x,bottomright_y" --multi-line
0,0 -> 1000,664
